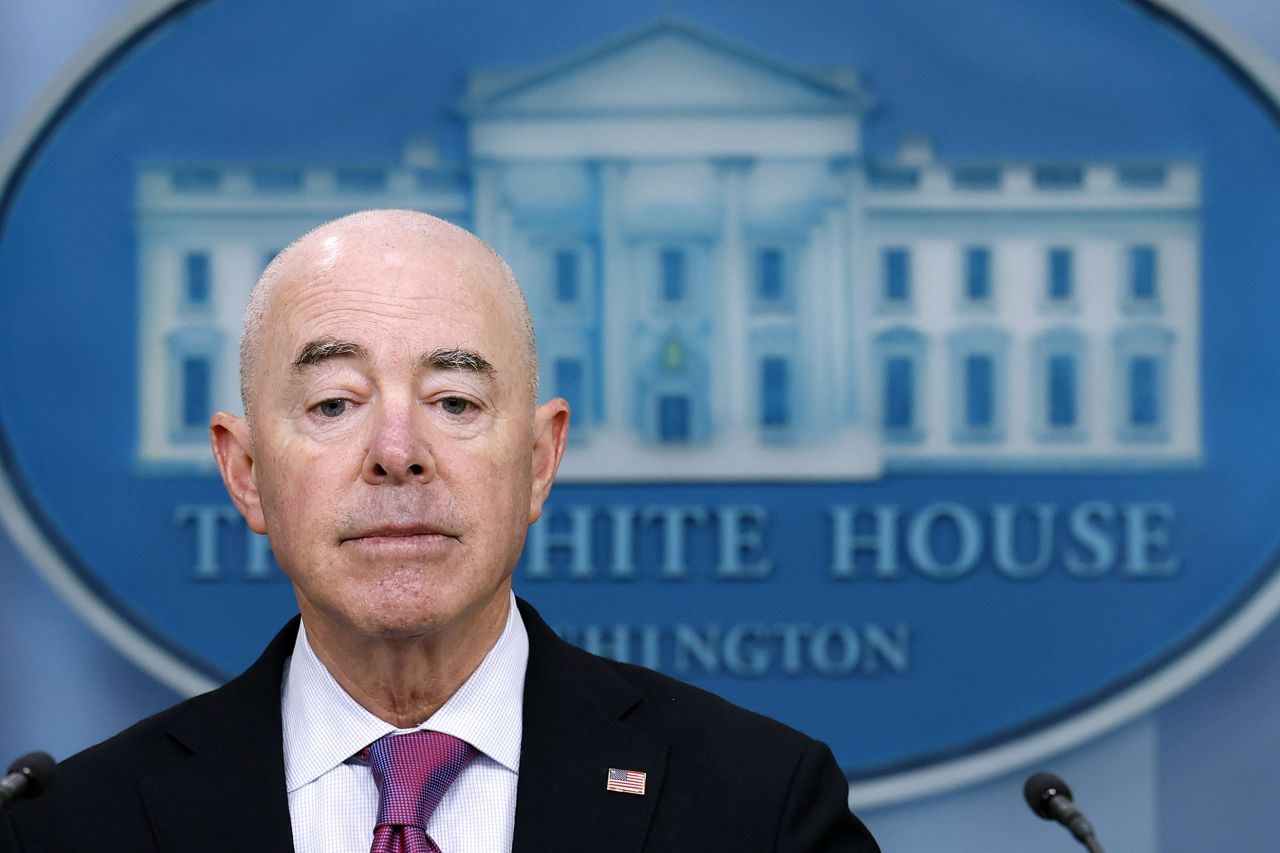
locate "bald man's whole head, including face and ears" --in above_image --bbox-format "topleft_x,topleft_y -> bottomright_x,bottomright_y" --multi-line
211,211 -> 568,638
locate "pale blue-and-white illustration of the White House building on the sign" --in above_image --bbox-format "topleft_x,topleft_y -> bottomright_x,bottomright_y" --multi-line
137,19 -> 1201,480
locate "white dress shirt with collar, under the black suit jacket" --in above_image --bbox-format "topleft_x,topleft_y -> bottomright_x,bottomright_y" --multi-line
280,596 -> 529,853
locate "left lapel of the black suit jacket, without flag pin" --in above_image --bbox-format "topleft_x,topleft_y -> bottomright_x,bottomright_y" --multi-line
141,620 -> 297,853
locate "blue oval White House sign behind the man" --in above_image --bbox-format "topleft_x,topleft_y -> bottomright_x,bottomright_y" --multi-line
0,0 -> 1280,803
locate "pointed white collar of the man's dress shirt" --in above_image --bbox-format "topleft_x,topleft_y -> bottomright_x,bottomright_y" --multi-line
280,594 -> 529,793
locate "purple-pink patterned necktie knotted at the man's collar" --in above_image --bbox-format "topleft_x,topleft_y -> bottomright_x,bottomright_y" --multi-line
369,731 -> 476,853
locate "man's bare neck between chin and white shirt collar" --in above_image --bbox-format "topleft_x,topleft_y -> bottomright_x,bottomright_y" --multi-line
300,594 -> 511,729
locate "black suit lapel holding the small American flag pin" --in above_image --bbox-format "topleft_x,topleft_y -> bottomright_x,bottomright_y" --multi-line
512,602 -> 667,853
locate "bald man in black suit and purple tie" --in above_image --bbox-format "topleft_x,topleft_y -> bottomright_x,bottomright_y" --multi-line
0,211 -> 877,853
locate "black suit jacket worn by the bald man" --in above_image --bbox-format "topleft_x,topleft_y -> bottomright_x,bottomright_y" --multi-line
0,602 -> 878,853
